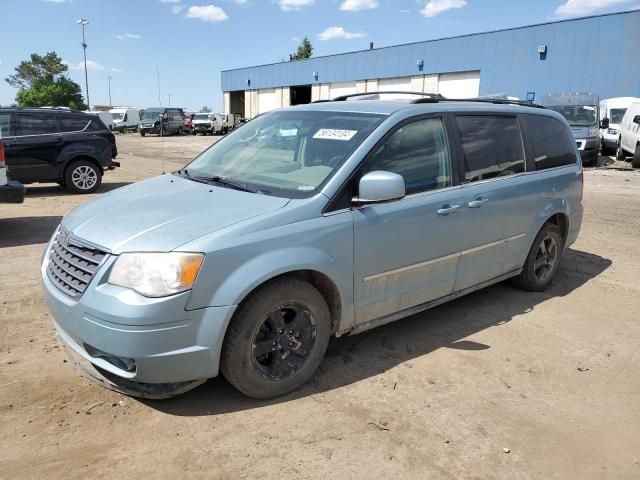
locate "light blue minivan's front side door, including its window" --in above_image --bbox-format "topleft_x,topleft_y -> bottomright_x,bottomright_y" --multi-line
353,117 -> 463,323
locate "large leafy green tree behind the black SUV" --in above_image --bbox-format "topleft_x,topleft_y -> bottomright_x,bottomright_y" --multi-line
5,52 -> 87,110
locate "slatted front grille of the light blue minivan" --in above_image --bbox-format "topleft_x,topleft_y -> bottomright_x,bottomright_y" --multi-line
47,229 -> 107,298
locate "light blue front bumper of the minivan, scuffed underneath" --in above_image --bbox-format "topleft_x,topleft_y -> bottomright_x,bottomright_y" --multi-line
41,249 -> 235,392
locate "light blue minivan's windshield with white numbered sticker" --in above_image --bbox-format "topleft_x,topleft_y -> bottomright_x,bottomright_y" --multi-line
181,110 -> 385,198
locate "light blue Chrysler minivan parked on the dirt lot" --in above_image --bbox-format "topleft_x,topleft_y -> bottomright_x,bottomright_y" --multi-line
42,94 -> 582,398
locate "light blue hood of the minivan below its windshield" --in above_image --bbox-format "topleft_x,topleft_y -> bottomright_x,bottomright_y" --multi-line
62,174 -> 289,254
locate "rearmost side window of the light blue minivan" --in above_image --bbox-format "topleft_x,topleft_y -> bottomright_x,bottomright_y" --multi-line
522,115 -> 576,170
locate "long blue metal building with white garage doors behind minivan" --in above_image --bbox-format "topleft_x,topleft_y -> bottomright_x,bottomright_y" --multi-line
222,10 -> 640,117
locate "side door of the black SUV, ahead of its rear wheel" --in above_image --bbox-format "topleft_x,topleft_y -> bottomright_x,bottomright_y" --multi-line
6,112 -> 64,183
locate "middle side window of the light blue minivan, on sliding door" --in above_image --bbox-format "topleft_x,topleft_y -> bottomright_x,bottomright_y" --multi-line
456,115 -> 525,182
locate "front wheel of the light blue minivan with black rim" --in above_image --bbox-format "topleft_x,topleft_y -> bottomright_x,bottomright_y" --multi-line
220,278 -> 331,399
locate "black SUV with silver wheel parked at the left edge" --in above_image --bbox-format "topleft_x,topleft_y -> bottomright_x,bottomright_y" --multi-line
0,108 -> 120,193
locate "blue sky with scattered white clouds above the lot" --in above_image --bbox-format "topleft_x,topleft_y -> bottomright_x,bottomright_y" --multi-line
0,0 -> 640,110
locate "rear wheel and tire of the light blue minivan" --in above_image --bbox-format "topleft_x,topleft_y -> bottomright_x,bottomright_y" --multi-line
512,223 -> 564,292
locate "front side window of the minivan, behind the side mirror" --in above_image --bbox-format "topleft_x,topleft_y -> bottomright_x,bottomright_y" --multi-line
363,118 -> 451,195
